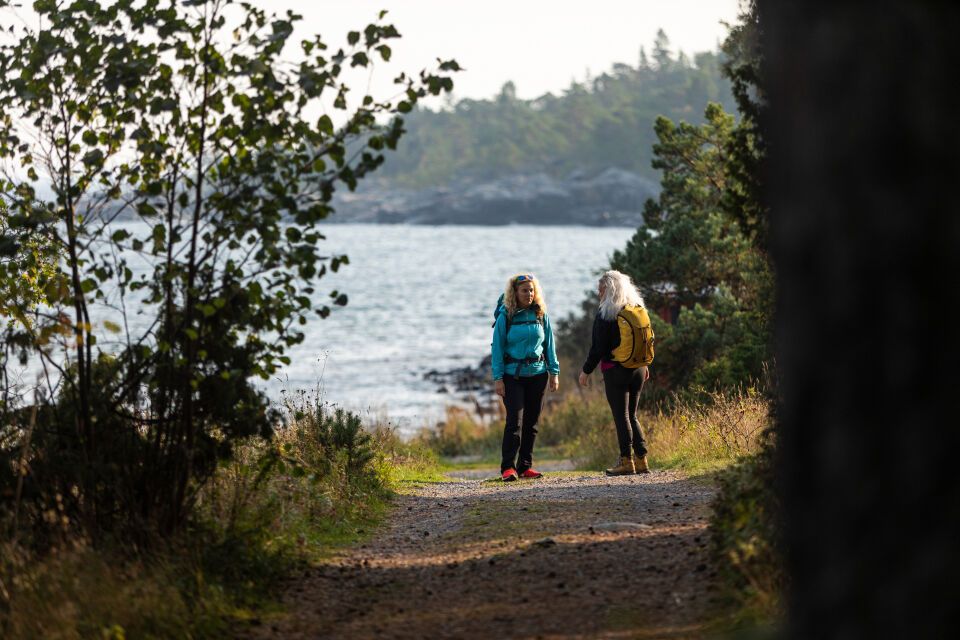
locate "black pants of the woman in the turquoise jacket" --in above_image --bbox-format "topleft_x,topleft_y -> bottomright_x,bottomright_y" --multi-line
500,371 -> 547,473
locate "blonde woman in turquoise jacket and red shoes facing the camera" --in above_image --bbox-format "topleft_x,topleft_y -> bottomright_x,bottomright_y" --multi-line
491,274 -> 560,482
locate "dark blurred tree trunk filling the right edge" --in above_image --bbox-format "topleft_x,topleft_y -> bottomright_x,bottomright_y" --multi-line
760,0 -> 960,639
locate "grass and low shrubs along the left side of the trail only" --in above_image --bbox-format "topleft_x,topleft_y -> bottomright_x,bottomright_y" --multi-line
0,402 -> 443,640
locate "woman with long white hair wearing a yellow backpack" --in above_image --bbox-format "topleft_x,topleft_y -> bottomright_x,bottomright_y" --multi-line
580,271 -> 652,476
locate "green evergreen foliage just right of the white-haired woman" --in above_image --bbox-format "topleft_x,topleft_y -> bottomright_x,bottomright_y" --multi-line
611,104 -> 773,389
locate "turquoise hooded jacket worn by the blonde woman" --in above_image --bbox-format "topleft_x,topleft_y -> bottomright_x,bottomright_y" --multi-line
490,309 -> 560,380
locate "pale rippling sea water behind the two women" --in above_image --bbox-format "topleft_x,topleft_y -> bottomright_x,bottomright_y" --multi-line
11,222 -> 634,434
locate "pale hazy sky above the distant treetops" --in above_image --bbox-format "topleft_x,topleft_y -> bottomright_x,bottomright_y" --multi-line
266,0 -> 739,99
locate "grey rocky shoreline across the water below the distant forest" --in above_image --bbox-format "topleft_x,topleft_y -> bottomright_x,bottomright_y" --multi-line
329,167 -> 659,227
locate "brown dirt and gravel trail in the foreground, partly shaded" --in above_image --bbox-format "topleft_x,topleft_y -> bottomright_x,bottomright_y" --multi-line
250,469 -> 714,639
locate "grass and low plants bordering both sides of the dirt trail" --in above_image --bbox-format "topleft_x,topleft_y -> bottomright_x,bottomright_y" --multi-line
0,388 -> 779,638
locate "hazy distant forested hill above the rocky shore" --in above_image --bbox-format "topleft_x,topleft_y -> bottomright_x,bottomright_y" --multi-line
380,30 -> 735,187
